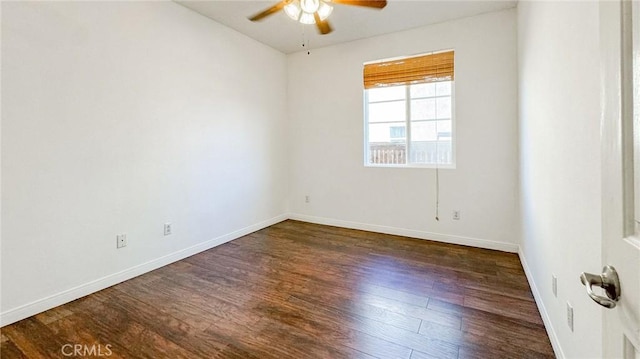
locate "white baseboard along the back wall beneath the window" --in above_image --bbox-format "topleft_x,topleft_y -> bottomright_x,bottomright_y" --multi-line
289,213 -> 519,253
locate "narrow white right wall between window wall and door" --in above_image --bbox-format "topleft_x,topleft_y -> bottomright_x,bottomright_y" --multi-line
518,1 -> 602,358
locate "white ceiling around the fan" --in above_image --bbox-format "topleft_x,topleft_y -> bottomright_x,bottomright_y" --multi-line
174,0 -> 516,54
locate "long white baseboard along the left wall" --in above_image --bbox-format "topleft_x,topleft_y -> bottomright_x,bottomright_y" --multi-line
0,214 -> 288,327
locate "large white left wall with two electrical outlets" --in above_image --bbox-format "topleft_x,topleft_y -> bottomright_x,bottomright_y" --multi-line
1,2 -> 288,324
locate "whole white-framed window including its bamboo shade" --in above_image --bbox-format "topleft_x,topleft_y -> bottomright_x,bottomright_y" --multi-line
364,51 -> 455,168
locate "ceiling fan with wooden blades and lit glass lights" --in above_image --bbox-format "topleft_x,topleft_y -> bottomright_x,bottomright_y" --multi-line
249,0 -> 387,35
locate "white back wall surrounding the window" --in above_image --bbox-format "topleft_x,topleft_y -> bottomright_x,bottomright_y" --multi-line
288,9 -> 519,251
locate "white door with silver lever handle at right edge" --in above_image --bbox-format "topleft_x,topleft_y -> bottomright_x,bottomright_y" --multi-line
592,0 -> 640,359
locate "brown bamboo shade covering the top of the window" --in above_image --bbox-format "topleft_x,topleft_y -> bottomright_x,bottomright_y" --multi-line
364,51 -> 453,89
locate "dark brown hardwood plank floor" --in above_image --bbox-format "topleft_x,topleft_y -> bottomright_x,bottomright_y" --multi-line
0,221 -> 553,359
